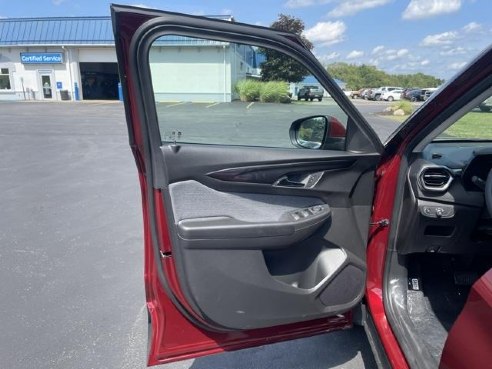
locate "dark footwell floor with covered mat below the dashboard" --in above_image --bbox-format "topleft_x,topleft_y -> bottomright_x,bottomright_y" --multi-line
407,254 -> 491,362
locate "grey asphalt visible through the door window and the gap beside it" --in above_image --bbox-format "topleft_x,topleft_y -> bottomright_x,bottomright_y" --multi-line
157,99 -> 398,148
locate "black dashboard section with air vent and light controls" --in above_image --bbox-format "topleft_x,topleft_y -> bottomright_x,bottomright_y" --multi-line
397,141 -> 492,254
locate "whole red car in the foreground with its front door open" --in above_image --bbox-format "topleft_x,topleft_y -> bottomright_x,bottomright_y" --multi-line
111,5 -> 492,369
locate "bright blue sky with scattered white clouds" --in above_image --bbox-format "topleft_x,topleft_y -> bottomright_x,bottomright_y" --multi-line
0,0 -> 492,79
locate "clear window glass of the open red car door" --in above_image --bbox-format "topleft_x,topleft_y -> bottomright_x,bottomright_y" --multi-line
149,36 -> 347,149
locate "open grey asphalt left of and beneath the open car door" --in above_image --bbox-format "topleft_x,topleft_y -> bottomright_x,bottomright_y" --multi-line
0,102 -> 397,369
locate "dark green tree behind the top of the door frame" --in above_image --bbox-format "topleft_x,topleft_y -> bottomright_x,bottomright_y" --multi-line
260,14 -> 313,82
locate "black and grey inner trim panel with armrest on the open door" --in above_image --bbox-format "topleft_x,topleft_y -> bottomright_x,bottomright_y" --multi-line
161,144 -> 378,330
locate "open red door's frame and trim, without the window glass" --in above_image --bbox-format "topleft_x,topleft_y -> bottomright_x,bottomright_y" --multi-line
112,6 -> 382,364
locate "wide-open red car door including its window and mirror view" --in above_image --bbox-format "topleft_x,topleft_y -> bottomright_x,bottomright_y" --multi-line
111,5 -> 383,365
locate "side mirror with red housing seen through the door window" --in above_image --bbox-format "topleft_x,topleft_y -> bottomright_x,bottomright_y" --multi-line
289,115 -> 347,150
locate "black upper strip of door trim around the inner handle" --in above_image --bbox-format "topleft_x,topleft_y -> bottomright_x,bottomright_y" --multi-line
161,144 -> 380,206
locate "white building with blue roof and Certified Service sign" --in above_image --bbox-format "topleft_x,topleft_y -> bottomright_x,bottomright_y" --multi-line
0,16 -> 257,102
